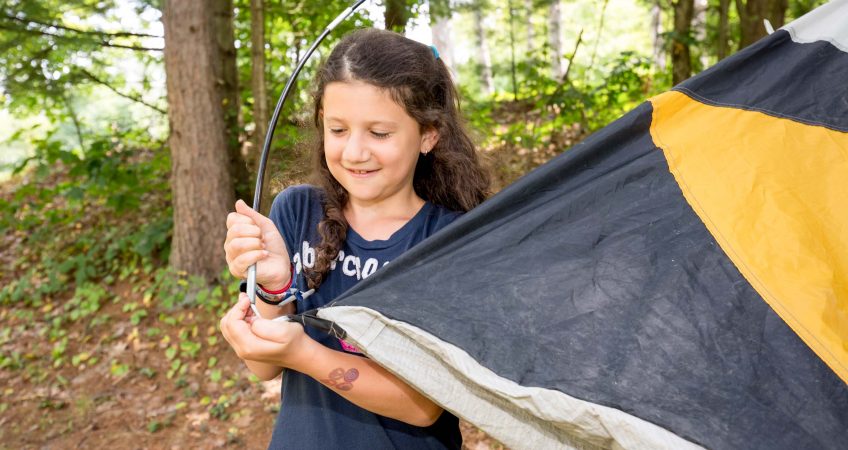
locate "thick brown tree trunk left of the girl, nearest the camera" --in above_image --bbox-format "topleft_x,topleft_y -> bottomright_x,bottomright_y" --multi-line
162,0 -> 233,279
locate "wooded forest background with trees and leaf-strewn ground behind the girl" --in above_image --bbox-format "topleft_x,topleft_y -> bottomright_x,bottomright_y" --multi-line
0,0 -> 825,449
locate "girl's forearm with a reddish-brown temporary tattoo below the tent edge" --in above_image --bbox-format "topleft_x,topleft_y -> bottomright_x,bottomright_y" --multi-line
286,338 -> 442,427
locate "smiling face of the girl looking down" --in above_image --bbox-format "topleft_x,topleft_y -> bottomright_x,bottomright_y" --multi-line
321,81 -> 438,205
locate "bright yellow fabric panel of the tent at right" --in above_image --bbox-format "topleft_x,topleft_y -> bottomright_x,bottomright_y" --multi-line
651,91 -> 848,381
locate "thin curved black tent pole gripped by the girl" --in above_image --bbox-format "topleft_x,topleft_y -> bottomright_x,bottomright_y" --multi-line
247,0 -> 365,317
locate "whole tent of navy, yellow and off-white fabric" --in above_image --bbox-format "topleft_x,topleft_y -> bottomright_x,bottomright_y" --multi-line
308,0 -> 848,449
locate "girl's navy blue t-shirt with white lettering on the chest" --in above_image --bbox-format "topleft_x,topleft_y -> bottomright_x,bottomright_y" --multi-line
269,185 -> 462,450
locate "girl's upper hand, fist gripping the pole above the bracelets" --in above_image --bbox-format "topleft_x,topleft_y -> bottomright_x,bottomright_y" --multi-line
224,200 -> 291,291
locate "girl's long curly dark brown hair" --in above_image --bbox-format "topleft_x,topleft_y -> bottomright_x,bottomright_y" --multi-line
304,29 -> 490,289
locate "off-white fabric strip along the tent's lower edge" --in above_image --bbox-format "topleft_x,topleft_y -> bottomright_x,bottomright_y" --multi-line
318,306 -> 703,450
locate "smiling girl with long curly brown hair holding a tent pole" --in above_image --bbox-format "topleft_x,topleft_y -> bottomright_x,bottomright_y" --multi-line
221,30 -> 489,449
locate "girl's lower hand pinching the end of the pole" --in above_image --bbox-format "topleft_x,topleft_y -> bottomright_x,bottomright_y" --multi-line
220,293 -> 314,367
